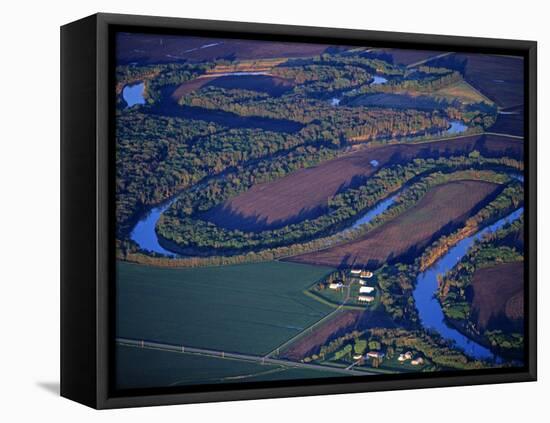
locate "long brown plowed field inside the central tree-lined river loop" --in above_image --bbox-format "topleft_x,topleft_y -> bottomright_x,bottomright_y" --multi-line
203,135 -> 523,231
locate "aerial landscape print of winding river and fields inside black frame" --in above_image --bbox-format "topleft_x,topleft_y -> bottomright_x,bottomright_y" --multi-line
113,33 -> 525,389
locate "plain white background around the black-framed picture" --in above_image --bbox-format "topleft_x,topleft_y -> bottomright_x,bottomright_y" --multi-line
0,0 -> 550,423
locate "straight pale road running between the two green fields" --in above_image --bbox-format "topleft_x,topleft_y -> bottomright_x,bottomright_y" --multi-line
116,338 -> 374,376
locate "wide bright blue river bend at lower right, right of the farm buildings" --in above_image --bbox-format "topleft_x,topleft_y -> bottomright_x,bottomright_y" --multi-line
413,207 -> 523,362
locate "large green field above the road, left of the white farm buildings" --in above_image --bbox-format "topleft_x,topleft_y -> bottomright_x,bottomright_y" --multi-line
117,262 -> 333,355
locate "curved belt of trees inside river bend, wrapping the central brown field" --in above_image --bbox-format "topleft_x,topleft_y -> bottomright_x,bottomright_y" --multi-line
157,157 -> 524,254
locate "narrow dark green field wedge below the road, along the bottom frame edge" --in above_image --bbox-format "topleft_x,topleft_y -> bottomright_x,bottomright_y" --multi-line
116,345 -> 339,389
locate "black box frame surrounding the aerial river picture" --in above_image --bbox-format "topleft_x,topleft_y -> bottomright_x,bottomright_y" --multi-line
61,13 -> 537,409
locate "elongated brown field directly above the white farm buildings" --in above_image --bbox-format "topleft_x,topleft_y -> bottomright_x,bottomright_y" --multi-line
288,180 -> 498,268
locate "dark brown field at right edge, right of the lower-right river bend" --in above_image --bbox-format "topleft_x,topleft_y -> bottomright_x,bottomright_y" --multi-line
472,262 -> 523,329
